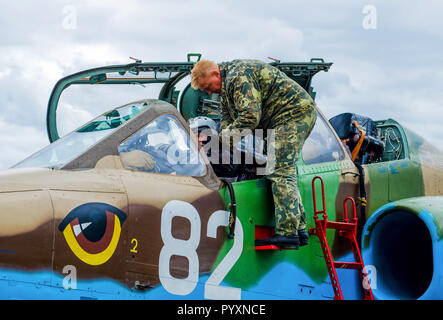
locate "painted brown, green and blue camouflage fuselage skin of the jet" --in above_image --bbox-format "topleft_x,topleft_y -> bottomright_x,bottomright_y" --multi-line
0,59 -> 443,299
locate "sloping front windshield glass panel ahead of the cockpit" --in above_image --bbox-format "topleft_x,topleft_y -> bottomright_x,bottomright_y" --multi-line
13,101 -> 148,169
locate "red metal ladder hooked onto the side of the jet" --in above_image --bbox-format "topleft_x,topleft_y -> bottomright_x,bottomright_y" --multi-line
309,176 -> 374,300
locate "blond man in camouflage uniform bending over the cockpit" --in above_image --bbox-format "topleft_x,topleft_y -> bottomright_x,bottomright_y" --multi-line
191,60 -> 317,248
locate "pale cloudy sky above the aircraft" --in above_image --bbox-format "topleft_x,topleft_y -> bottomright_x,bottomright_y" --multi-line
0,0 -> 443,169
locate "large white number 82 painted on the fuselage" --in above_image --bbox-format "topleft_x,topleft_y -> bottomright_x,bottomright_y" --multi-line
158,200 -> 243,300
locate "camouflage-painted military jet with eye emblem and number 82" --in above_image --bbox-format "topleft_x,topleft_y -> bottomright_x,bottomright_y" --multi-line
0,54 -> 443,299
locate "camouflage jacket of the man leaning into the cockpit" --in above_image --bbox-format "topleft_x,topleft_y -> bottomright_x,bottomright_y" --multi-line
219,60 -> 314,130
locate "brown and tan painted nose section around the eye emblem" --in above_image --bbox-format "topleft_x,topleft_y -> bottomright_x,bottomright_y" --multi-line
0,164 -> 224,298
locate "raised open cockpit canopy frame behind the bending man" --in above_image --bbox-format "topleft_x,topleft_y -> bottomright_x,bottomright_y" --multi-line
46,53 -> 332,142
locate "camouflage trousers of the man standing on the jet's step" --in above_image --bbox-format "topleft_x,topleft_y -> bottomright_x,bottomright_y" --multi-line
267,104 -> 317,236
